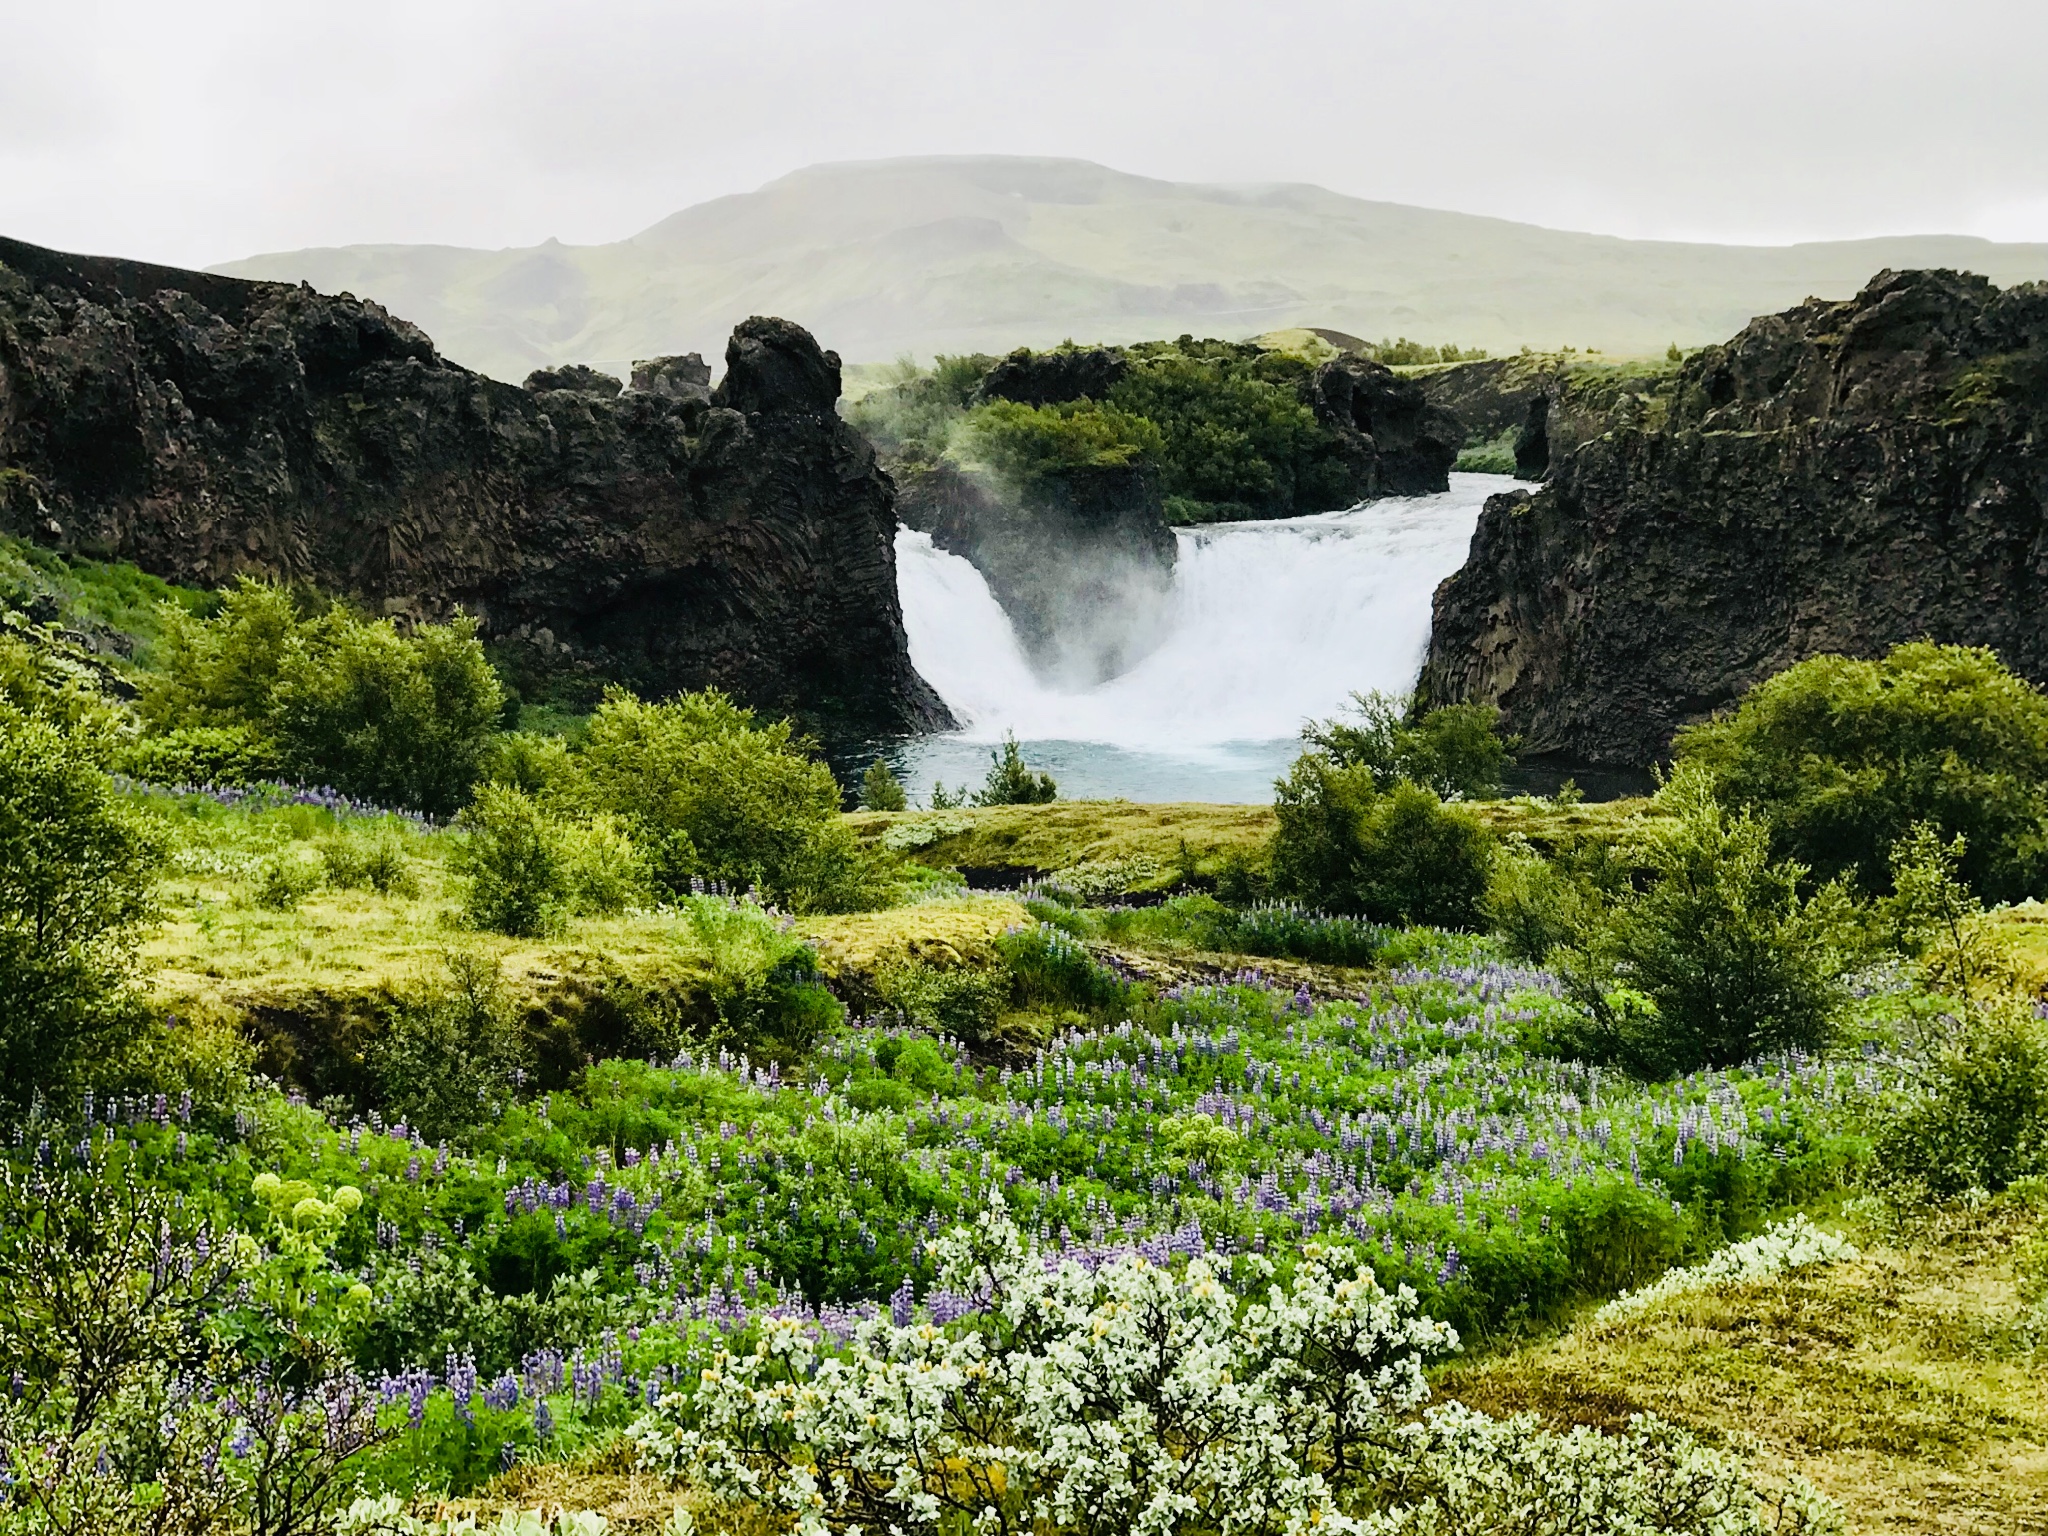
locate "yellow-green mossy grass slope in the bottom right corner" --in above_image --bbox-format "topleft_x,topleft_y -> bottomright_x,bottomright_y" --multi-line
1440,1202 -> 2048,1532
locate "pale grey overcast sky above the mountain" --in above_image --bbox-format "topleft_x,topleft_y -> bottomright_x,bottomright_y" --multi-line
0,0 -> 2048,266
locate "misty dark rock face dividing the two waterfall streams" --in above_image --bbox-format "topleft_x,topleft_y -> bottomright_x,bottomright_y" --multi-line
897,463 -> 1178,688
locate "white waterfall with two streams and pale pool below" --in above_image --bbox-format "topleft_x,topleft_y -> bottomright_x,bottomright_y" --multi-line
897,475 -> 1513,799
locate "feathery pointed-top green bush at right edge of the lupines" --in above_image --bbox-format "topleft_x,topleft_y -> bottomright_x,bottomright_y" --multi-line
1554,770 -> 1841,1077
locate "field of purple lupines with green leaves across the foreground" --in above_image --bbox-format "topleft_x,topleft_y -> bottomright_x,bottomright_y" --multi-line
10,888 -> 1888,1495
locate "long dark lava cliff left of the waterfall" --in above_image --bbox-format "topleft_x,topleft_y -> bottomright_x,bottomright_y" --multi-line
0,242 -> 950,733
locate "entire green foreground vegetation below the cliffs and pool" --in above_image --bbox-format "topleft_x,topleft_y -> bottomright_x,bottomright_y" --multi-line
0,532 -> 2048,1536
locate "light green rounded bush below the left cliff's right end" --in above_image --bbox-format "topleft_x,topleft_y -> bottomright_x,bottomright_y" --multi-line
582,690 -> 889,911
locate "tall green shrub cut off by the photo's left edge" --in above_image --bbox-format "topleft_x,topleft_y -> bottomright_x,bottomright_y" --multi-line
0,707 -> 164,1104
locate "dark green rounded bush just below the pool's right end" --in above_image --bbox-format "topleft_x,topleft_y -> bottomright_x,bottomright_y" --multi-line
1272,752 -> 1493,928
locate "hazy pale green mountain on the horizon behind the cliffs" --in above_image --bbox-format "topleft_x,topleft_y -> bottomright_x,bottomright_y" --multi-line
213,156 -> 2048,379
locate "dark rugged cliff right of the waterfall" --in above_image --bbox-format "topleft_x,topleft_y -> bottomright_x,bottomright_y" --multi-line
1421,272 -> 2048,764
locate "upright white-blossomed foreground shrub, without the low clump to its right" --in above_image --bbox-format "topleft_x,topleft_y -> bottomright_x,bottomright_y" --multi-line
635,1212 -> 1458,1536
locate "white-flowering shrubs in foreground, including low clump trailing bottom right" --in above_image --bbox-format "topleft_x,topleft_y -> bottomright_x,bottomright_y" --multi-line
633,1208 -> 1829,1536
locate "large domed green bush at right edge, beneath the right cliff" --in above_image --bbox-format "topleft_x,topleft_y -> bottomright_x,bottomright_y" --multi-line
1675,641 -> 2048,901
